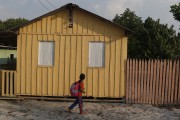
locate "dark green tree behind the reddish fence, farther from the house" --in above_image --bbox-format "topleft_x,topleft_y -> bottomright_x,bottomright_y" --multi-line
144,17 -> 176,58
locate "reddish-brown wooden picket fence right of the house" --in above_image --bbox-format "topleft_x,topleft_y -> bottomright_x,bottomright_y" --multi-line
126,59 -> 180,105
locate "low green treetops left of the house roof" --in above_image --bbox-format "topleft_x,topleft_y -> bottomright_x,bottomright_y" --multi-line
0,18 -> 28,31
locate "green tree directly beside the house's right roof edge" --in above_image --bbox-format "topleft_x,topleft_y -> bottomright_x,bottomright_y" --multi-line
113,9 -> 146,58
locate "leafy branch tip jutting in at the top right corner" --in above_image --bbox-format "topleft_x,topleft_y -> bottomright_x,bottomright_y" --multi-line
170,3 -> 180,22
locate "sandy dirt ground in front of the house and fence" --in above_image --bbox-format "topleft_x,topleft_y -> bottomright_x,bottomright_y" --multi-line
0,100 -> 180,120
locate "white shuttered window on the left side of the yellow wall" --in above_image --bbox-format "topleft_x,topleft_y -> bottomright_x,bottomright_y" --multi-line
38,41 -> 54,66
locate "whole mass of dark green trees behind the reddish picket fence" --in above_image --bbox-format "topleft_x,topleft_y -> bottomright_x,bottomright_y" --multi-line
113,9 -> 180,59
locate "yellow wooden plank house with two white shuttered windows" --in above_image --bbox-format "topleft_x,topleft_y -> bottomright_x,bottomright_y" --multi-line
1,3 -> 131,98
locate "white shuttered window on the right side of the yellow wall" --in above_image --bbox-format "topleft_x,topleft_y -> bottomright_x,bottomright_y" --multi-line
89,42 -> 105,67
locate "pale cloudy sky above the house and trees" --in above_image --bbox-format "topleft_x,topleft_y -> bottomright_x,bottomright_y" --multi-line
0,0 -> 180,32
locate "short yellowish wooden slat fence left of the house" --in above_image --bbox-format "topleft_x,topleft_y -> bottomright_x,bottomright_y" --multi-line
0,70 -> 16,97
